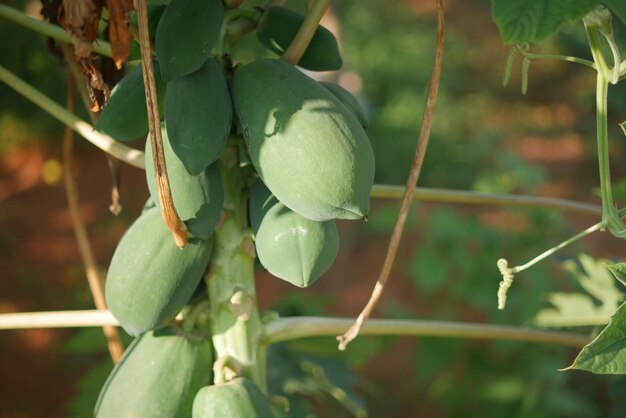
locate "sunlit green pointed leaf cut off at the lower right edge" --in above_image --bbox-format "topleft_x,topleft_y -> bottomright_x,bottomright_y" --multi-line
565,304 -> 626,374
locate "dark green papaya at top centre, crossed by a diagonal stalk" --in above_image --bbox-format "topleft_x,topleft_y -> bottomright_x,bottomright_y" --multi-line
256,6 -> 343,71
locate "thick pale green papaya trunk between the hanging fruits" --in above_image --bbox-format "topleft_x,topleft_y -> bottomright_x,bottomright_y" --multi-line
205,146 -> 266,390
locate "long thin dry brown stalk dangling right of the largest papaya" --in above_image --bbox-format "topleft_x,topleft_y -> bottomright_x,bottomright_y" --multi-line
337,0 -> 444,350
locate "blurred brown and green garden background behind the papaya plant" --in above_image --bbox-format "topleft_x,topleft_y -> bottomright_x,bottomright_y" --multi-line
0,0 -> 626,418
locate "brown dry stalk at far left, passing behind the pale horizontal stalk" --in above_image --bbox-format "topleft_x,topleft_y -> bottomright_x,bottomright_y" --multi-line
63,76 -> 124,364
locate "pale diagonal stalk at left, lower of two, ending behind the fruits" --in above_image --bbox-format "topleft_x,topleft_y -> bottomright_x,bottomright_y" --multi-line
0,65 -> 145,168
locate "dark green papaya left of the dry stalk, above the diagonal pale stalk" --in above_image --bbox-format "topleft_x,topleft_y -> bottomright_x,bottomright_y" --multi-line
96,62 -> 166,141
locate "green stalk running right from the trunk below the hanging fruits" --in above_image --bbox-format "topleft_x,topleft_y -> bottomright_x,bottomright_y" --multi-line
265,316 -> 590,348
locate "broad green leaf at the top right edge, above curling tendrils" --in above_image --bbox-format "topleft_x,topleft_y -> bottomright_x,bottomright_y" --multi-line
491,0 -> 596,45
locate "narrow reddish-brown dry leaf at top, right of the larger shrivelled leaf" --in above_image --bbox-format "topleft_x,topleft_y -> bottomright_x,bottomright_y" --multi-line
107,0 -> 134,69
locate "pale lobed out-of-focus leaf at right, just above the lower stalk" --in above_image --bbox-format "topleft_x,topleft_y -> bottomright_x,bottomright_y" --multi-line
534,254 -> 624,327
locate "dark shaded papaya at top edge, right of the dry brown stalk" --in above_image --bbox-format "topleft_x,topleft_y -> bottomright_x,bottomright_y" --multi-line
154,0 -> 224,81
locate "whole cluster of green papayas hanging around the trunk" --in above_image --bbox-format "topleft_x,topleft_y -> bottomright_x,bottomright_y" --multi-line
95,0 -> 374,418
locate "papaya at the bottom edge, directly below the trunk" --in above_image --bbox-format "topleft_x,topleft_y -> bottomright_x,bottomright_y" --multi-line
192,377 -> 275,418
